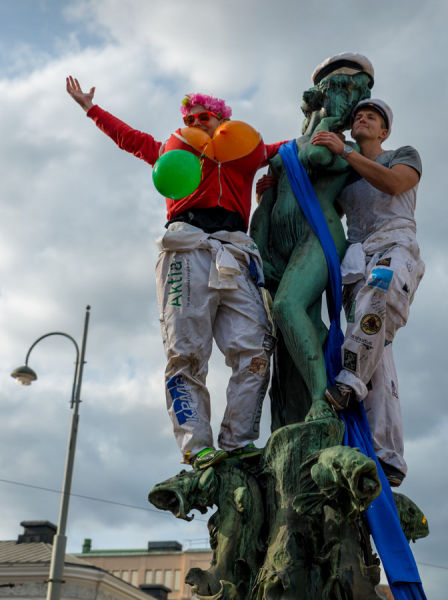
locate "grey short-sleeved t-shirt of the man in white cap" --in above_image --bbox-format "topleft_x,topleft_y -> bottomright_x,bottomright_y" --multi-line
338,146 -> 422,254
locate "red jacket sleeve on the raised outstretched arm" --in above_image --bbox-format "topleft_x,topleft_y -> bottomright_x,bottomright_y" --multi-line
87,104 -> 162,165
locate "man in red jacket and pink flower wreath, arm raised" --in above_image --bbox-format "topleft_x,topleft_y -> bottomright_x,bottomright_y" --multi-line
66,76 -> 283,469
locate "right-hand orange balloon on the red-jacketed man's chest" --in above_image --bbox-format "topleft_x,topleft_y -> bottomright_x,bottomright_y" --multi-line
213,121 -> 261,162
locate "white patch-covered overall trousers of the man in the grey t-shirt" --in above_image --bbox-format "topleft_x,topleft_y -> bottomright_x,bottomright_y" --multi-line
336,246 -> 424,474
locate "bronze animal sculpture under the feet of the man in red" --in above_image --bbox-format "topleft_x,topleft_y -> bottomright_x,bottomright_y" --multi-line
149,459 -> 266,599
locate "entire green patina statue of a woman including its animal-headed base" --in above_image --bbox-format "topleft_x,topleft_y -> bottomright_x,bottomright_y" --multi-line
149,55 -> 428,600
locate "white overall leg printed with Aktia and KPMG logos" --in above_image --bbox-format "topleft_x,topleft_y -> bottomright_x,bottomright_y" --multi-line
156,250 -> 219,456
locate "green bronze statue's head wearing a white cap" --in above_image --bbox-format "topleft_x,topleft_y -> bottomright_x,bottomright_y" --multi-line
302,52 -> 374,133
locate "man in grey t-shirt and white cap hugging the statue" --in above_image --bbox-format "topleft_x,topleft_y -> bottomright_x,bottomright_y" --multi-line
312,99 -> 425,486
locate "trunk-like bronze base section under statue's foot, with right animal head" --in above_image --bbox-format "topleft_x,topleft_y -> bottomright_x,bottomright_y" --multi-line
250,419 -> 381,600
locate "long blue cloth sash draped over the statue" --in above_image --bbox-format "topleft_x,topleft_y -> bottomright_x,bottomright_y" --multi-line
279,140 -> 426,600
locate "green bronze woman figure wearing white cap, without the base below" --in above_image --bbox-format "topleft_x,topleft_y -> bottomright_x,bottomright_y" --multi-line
251,52 -> 374,430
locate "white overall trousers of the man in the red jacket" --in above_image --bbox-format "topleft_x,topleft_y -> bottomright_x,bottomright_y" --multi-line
156,238 -> 272,462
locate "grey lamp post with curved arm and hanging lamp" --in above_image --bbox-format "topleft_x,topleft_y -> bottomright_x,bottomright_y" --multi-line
11,306 -> 90,600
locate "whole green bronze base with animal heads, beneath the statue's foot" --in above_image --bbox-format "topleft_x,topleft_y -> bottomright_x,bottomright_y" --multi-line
149,419 -> 381,600
